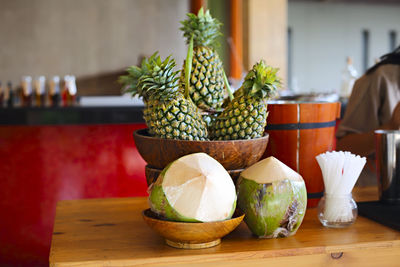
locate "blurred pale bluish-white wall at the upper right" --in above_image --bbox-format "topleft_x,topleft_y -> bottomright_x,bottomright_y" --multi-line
288,2 -> 400,93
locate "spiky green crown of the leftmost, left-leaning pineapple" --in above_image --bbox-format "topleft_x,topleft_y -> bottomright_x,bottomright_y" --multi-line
119,52 -> 179,101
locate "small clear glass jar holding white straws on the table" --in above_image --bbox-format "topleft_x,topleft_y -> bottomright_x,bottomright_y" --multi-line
318,193 -> 358,228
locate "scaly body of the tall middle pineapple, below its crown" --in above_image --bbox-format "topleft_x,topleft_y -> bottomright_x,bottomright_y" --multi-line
181,46 -> 225,110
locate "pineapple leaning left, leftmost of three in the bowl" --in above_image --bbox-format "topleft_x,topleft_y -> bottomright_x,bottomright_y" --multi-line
120,53 -> 208,140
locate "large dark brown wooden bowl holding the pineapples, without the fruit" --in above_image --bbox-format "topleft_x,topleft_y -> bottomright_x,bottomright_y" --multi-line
133,129 -> 269,170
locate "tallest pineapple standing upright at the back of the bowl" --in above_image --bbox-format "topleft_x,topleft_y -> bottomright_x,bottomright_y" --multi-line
180,8 -> 225,111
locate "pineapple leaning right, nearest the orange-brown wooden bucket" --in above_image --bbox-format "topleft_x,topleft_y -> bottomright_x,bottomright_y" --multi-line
211,61 -> 280,140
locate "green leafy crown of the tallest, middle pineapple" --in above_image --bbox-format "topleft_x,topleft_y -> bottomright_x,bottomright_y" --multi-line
180,8 -> 222,48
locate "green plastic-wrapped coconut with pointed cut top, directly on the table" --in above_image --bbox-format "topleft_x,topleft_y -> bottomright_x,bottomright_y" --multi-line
237,157 -> 307,238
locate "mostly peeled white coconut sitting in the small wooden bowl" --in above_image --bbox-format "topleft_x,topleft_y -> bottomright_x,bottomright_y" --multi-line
149,153 -> 236,222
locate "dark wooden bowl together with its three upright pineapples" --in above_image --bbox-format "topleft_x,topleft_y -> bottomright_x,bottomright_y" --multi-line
120,10 -> 280,183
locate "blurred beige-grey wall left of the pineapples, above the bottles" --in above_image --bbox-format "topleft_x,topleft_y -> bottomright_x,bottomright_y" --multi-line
0,0 -> 189,92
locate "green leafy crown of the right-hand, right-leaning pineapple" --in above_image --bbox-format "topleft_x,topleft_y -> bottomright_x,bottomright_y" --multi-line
242,60 -> 281,99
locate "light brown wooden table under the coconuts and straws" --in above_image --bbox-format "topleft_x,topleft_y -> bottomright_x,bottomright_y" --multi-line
50,188 -> 400,267
